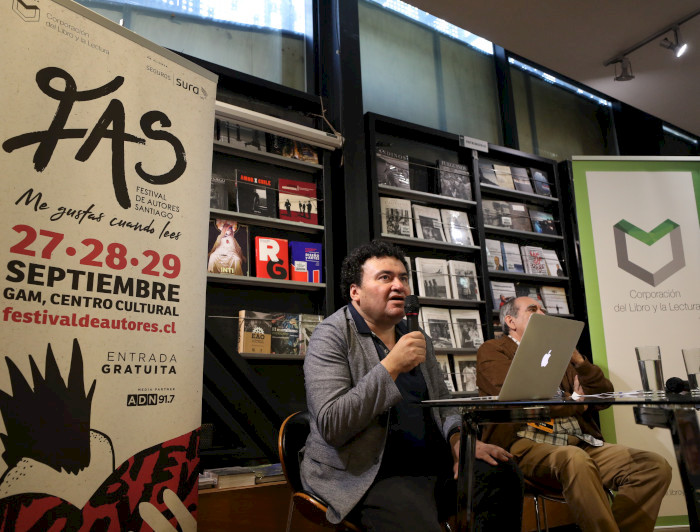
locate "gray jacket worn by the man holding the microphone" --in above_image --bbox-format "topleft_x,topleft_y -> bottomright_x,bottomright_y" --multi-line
301,307 -> 460,523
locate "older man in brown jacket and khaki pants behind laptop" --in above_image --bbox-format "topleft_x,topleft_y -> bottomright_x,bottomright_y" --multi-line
476,297 -> 671,532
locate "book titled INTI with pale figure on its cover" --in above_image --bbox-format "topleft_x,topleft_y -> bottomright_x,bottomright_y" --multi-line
207,218 -> 249,275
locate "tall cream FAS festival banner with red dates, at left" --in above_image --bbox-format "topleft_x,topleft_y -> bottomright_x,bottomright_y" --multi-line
0,0 -> 216,530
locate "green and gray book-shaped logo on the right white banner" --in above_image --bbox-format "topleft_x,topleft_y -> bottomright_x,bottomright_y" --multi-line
613,219 -> 685,286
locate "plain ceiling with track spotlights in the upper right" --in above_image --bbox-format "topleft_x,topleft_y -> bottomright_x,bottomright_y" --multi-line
407,0 -> 700,137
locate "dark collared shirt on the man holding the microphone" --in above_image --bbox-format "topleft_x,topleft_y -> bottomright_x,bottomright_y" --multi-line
348,303 -> 449,478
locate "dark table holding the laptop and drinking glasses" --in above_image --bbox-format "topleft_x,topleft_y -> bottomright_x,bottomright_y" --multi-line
421,393 -> 700,531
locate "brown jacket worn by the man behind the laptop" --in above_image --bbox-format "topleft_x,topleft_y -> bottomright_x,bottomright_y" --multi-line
476,336 -> 613,449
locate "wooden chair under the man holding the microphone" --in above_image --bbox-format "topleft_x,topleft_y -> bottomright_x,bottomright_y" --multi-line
278,411 -> 361,532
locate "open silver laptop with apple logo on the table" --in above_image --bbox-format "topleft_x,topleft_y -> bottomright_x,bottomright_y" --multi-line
423,314 -> 584,404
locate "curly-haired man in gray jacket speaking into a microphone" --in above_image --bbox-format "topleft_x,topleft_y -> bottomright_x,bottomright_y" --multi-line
301,241 -> 523,532
